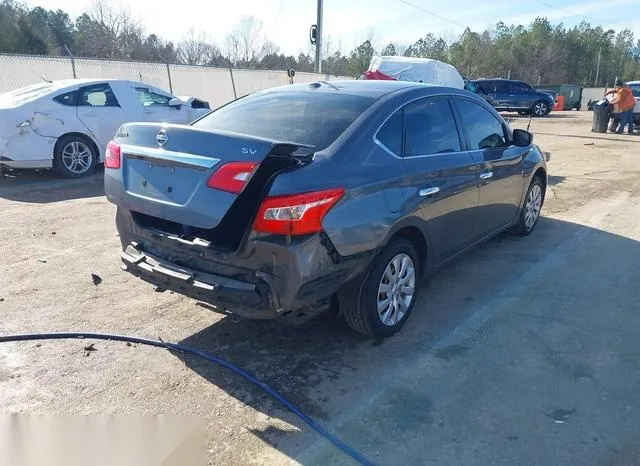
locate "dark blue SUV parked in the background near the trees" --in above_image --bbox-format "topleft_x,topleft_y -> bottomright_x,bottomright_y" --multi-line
465,79 -> 554,117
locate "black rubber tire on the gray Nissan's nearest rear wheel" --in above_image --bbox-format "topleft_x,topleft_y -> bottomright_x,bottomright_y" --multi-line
339,238 -> 420,338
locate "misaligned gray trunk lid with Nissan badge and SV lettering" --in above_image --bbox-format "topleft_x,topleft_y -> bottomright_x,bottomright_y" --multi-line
105,123 -> 310,246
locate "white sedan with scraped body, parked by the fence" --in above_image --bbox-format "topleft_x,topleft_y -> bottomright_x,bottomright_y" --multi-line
0,79 -> 210,178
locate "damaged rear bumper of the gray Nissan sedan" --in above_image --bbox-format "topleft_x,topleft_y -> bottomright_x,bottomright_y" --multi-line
116,207 -> 372,319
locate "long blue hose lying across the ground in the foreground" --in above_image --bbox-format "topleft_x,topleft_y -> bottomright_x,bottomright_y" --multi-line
0,332 -> 374,465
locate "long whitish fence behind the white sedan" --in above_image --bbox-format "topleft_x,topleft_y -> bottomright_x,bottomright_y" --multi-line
0,55 -> 352,108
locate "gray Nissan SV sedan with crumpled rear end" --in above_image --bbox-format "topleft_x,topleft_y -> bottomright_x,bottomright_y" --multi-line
105,81 -> 547,338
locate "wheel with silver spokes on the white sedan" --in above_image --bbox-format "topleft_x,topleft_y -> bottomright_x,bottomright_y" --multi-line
53,134 -> 98,178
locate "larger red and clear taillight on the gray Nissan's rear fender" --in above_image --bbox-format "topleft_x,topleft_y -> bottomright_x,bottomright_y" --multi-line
253,188 -> 344,235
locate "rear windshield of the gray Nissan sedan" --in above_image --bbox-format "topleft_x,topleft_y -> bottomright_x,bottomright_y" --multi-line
193,92 -> 375,150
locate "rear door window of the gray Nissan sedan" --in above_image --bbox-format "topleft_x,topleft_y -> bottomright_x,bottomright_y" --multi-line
403,98 -> 462,157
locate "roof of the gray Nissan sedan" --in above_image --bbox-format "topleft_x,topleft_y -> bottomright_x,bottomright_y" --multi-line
256,79 -> 462,99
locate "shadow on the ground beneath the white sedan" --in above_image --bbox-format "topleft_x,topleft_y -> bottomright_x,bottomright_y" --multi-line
0,166 -> 104,204
